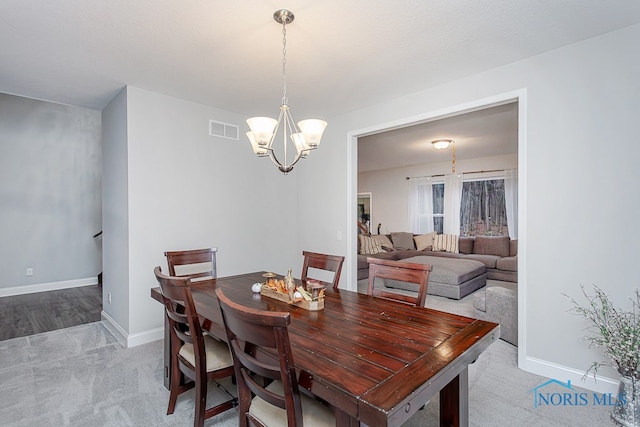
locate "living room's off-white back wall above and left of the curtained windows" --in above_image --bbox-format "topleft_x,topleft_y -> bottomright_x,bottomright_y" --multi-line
358,154 -> 518,234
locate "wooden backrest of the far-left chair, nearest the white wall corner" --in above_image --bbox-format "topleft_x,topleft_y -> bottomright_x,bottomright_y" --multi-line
164,248 -> 218,279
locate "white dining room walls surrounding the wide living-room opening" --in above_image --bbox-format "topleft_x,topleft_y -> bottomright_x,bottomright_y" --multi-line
105,21 -> 640,391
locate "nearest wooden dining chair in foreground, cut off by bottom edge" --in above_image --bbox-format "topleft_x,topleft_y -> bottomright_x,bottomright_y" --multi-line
216,288 -> 336,427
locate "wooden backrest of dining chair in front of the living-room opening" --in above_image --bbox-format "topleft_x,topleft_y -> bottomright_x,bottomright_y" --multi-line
367,257 -> 431,307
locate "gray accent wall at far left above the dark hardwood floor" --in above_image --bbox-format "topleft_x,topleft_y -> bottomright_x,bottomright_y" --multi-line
0,94 -> 102,294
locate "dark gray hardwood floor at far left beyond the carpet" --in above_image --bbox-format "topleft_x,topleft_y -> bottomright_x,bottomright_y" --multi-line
0,285 -> 102,341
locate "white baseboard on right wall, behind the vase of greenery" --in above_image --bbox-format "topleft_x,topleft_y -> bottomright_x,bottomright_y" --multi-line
520,356 -> 619,395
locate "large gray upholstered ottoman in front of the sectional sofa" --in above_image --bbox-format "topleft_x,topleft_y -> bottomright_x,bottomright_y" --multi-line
384,255 -> 487,299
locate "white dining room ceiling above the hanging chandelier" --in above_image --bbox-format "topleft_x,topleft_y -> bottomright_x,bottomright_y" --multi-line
0,0 -> 640,122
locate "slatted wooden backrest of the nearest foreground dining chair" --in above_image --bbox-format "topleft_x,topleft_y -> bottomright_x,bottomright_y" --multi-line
216,288 -> 302,427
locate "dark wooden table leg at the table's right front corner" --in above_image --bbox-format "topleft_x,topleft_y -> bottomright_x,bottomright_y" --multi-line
440,367 -> 469,427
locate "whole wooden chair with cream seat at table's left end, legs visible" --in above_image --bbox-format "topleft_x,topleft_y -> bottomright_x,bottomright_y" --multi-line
154,266 -> 238,427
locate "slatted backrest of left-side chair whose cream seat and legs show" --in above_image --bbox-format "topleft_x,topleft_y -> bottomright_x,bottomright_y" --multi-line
153,266 -> 207,375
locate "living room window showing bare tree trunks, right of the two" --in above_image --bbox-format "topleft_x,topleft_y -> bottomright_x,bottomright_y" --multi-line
462,179 -> 509,236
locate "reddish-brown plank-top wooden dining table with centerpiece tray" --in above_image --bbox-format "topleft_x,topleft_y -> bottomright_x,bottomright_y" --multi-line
151,272 -> 500,426
